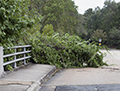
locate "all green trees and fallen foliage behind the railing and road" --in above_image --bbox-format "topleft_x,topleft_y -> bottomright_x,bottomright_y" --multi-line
0,0 -> 120,69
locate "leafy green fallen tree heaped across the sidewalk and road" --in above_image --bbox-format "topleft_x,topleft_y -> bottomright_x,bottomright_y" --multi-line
31,33 -> 105,68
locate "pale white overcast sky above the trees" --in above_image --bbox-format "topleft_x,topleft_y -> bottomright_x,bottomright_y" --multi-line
73,0 -> 120,14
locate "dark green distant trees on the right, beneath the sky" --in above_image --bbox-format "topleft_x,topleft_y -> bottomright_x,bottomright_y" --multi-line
83,0 -> 120,47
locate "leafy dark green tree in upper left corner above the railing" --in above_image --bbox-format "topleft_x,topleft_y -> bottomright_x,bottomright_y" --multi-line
0,0 -> 34,41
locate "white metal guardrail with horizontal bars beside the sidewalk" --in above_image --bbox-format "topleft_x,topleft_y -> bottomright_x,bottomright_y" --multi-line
0,45 -> 31,76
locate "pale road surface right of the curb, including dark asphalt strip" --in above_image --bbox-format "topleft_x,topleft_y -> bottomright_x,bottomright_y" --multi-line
39,50 -> 120,91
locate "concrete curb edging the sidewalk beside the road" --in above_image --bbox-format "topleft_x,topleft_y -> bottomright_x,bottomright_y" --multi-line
26,66 -> 56,91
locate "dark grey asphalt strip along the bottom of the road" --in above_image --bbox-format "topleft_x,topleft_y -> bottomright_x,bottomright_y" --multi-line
55,84 -> 120,91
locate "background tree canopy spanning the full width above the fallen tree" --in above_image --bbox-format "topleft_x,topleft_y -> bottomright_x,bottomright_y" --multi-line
0,0 -> 120,48
